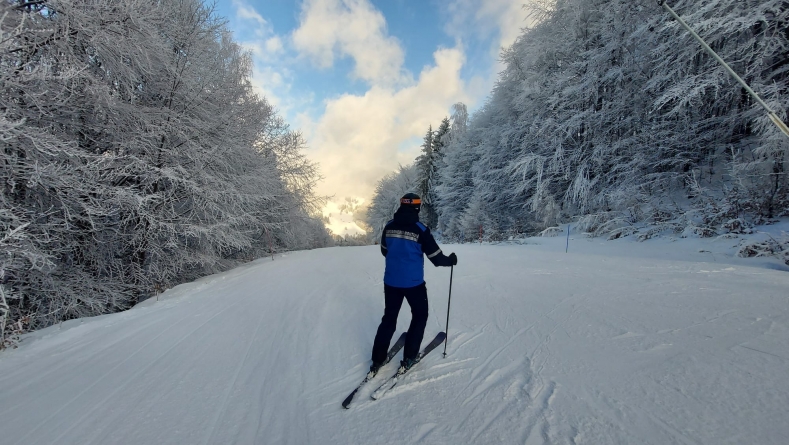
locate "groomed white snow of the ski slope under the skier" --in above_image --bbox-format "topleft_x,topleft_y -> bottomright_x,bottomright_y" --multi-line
0,237 -> 789,445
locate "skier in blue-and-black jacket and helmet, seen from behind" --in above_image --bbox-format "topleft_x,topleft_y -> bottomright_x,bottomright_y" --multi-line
370,193 -> 457,375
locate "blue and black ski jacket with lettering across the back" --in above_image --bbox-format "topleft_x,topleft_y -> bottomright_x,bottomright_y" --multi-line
381,206 -> 452,288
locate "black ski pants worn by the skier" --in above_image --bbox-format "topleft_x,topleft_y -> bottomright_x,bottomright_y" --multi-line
373,283 -> 427,363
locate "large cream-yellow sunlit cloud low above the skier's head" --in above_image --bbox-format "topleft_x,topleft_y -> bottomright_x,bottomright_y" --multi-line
304,48 -> 470,198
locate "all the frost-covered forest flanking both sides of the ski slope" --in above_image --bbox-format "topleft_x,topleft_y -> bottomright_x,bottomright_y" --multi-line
0,0 -> 789,347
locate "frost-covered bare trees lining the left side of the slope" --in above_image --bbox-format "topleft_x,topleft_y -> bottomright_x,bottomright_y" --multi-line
0,0 -> 331,344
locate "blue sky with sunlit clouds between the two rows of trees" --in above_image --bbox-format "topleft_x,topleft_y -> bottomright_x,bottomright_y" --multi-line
215,0 -> 528,232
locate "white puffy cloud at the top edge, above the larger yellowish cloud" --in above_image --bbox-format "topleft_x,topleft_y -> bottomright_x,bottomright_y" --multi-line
293,0 -> 409,86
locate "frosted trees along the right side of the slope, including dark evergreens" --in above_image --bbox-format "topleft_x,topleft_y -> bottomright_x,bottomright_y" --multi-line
369,0 -> 789,241
